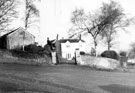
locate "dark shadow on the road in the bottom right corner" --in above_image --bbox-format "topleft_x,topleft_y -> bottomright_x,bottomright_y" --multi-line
99,84 -> 135,93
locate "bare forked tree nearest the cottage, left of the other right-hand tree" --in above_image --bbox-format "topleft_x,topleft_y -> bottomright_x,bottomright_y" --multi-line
69,9 -> 108,55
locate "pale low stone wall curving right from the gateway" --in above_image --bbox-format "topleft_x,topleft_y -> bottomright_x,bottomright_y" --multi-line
78,55 -> 120,70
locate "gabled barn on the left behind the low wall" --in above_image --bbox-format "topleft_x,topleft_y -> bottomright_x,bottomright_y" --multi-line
0,27 -> 35,49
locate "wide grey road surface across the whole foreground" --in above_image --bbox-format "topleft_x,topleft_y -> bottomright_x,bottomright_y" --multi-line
0,64 -> 135,93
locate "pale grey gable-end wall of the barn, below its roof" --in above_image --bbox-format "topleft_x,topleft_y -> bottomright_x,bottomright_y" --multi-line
7,30 -> 35,49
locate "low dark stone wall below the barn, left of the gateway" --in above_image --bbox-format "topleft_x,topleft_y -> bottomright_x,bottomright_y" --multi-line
0,50 -> 51,65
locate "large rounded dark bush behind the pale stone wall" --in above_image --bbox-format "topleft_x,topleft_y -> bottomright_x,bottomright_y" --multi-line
101,50 -> 119,60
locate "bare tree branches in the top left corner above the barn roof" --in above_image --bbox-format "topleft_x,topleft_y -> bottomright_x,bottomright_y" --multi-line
0,0 -> 17,31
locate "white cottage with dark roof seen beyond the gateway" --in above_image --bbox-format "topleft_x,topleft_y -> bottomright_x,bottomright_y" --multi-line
59,39 -> 85,60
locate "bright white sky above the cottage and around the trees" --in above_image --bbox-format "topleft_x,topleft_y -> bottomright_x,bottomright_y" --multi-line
7,0 -> 135,50
